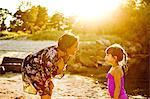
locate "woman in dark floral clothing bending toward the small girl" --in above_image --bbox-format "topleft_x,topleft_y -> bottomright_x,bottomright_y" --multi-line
22,33 -> 78,99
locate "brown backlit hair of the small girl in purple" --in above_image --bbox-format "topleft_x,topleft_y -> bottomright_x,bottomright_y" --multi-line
105,44 -> 128,74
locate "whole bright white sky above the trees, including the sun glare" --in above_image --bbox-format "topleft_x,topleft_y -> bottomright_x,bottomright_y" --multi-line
0,0 -> 126,20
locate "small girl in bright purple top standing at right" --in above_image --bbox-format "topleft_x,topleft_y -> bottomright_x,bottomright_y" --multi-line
105,44 -> 128,99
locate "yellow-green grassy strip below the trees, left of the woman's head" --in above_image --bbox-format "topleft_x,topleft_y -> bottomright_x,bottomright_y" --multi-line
0,30 -> 63,41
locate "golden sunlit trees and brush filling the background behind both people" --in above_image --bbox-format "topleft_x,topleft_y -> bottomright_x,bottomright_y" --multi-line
0,0 -> 150,95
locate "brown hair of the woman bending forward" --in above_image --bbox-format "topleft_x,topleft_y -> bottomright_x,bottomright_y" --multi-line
58,33 -> 79,52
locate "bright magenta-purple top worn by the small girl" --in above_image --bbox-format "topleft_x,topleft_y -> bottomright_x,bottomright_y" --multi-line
107,73 -> 128,99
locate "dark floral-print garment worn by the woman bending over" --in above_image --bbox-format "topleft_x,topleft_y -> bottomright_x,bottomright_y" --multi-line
22,46 -> 61,95
